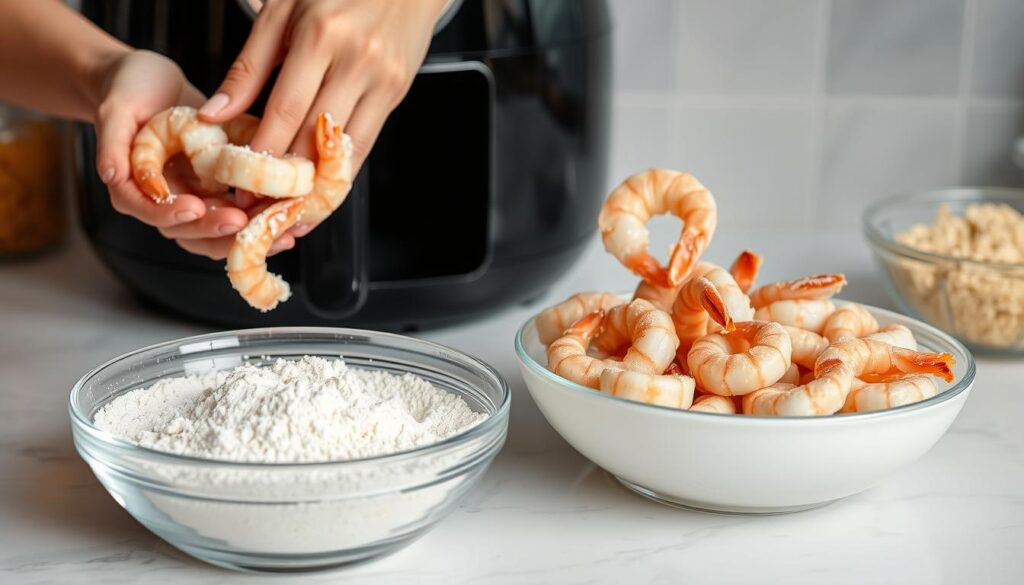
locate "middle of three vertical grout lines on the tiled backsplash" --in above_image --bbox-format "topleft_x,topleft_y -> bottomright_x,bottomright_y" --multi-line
803,0 -> 831,225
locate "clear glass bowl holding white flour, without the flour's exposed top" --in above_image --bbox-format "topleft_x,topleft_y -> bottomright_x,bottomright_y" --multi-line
69,328 -> 510,572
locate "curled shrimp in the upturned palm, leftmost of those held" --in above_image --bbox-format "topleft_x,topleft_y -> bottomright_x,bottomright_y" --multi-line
130,106 -> 227,203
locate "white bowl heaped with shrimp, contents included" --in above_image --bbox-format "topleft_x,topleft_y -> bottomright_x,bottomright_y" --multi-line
515,169 -> 975,513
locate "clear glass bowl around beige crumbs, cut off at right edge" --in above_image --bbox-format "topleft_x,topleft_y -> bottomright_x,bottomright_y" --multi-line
864,189 -> 1024,356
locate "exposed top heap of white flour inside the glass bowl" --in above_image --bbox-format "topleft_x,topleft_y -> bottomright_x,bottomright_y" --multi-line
94,357 -> 486,463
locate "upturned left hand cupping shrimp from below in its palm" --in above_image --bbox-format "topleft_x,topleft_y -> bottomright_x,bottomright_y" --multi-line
95,51 -> 295,259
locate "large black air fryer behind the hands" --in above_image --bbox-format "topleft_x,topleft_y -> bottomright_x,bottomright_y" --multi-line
78,0 -> 610,330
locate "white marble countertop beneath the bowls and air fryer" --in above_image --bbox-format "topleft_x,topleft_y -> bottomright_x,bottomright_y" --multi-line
0,226 -> 1024,584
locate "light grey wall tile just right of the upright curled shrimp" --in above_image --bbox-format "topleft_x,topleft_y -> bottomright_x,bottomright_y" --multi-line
676,107 -> 812,226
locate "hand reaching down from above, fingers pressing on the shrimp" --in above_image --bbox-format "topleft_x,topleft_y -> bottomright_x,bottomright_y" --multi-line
200,0 -> 445,201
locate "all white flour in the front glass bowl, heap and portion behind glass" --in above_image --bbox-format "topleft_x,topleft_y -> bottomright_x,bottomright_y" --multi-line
94,358 -> 499,558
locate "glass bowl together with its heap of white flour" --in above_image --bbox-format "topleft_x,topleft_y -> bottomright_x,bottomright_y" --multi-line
70,328 -> 510,572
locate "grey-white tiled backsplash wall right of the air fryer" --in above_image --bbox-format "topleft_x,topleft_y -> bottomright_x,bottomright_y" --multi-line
609,0 -> 1024,228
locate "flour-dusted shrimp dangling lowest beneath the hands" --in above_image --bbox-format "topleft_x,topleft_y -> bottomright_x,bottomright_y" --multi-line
227,199 -> 304,311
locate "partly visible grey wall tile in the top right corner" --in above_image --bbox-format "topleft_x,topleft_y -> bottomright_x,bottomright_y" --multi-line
971,0 -> 1024,98
